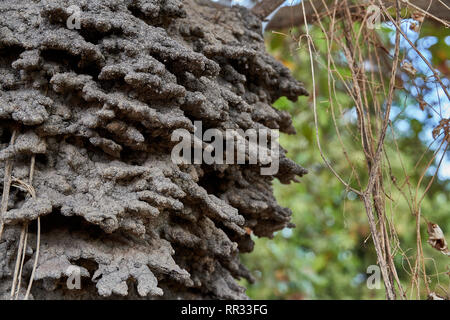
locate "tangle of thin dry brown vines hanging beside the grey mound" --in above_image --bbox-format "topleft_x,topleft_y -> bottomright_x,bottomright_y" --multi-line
272,0 -> 450,299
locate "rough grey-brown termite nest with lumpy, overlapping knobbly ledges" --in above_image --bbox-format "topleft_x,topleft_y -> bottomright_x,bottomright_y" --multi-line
0,0 -> 306,299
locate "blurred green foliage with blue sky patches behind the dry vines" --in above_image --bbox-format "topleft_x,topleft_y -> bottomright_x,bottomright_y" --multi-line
242,12 -> 450,299
